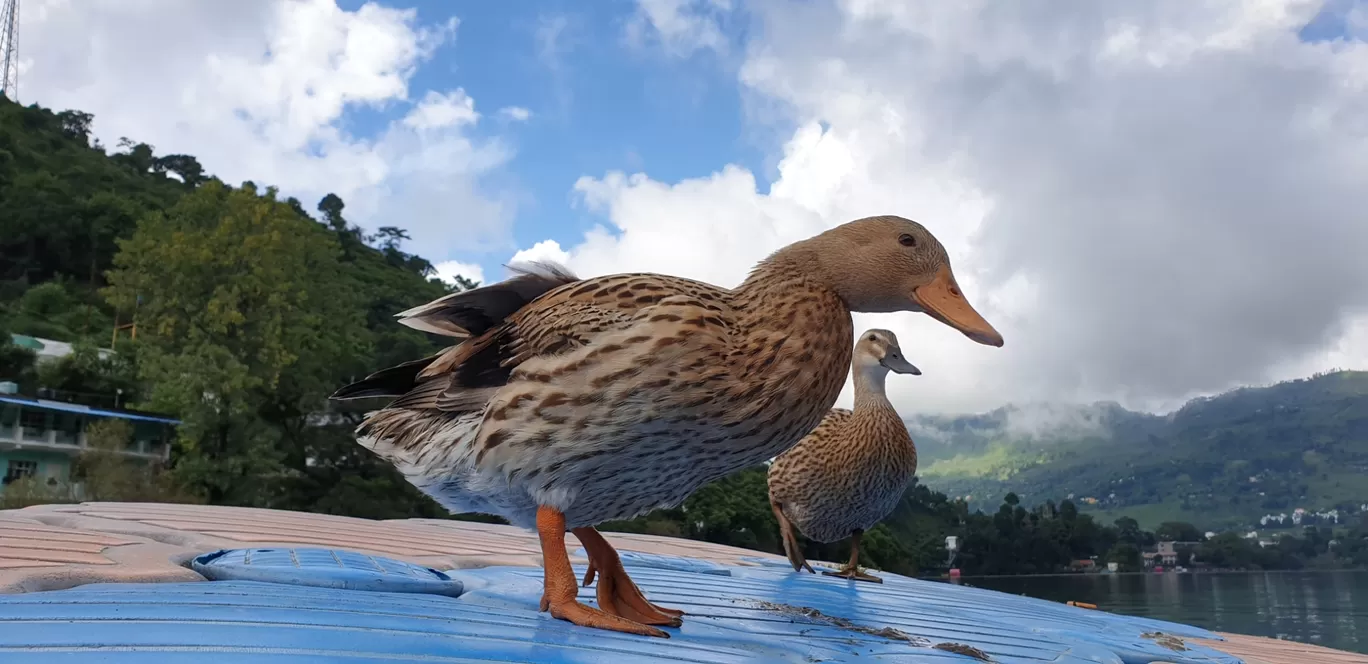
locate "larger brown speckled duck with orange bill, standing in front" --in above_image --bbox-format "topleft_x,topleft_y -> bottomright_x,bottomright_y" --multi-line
325,216 -> 1003,637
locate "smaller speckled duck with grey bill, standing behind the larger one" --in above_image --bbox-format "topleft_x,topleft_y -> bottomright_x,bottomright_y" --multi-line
769,330 -> 922,583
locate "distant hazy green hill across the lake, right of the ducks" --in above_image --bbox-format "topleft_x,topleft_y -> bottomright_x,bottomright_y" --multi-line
908,371 -> 1368,528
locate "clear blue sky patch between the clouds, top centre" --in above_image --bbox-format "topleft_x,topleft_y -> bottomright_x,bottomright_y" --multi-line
325,0 -> 769,278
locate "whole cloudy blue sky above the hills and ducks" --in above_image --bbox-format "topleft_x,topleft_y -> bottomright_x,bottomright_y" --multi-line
10,0 -> 1368,415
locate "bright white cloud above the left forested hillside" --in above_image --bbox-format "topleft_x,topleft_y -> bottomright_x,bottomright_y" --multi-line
22,0 -> 513,256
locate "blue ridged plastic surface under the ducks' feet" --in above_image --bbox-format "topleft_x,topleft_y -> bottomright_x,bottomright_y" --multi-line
0,549 -> 1241,664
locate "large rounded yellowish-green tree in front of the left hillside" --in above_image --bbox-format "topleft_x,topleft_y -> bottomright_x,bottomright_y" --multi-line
105,181 -> 364,504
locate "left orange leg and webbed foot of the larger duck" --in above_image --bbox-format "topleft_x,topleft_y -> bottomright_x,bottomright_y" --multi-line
536,507 -> 677,638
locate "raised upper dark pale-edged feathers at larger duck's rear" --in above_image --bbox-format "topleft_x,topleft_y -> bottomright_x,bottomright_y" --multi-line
398,263 -> 579,337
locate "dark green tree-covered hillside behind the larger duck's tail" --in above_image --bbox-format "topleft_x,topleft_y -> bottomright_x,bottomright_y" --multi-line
0,97 -> 470,518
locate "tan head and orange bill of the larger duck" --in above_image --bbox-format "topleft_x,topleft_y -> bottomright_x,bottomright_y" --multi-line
791,216 -> 1003,346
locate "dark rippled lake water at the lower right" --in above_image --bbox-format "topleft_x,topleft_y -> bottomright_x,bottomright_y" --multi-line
963,571 -> 1368,653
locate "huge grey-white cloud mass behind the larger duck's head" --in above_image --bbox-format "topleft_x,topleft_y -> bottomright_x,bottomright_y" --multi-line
514,0 -> 1368,413
